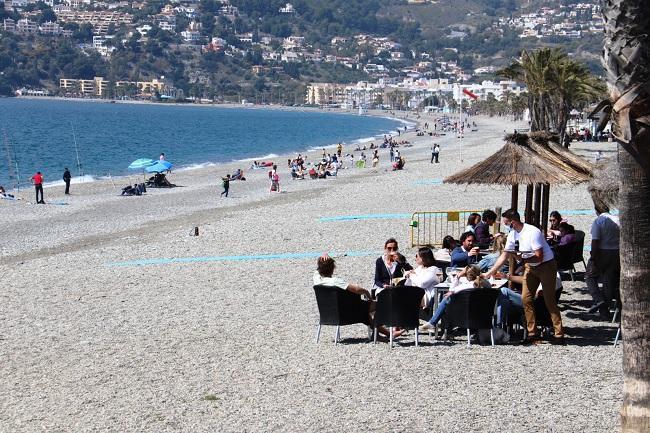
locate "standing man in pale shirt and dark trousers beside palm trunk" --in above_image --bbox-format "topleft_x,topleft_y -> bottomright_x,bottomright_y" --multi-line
585,201 -> 621,319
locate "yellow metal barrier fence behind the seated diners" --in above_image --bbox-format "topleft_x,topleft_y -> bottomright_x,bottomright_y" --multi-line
409,210 -> 483,248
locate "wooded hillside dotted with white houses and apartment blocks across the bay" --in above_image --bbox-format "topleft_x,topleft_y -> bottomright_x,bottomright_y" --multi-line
0,0 -> 603,106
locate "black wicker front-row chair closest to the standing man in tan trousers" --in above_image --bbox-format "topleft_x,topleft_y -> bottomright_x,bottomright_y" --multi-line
444,289 -> 499,346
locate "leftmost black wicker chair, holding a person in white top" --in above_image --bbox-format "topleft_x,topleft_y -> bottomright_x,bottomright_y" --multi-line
314,285 -> 369,344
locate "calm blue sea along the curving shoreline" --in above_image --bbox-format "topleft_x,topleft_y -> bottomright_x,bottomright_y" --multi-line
0,98 -> 401,187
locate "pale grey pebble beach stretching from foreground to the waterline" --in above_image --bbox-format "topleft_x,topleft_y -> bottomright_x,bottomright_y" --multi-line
0,113 -> 622,432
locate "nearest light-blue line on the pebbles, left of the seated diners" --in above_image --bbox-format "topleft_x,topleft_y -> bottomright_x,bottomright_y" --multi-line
105,251 -> 381,267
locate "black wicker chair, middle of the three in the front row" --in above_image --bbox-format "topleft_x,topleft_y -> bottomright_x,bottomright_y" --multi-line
374,286 -> 424,347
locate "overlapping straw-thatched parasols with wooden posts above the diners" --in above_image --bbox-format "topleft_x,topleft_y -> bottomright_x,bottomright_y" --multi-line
444,132 -> 592,231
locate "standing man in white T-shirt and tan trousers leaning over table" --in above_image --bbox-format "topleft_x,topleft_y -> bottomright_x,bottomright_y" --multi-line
484,209 -> 564,344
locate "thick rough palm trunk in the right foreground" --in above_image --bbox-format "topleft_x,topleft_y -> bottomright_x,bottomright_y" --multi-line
603,0 -> 650,432
